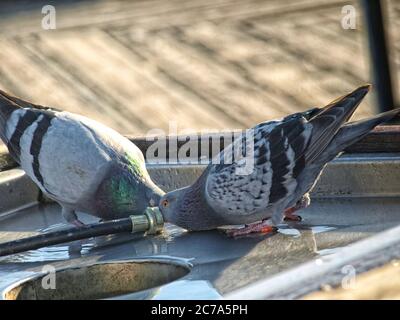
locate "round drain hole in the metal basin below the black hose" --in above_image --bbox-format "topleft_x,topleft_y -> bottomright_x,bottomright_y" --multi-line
4,261 -> 189,300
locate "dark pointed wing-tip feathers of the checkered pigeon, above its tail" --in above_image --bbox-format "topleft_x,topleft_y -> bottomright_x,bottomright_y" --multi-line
305,84 -> 371,163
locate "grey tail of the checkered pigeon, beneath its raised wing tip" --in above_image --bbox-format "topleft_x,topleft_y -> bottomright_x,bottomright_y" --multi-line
326,108 -> 400,157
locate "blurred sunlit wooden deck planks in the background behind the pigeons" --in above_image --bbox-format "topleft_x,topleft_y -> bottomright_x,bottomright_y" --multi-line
0,0 -> 400,134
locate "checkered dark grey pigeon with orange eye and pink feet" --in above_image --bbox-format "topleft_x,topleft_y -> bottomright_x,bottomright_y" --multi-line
159,85 -> 400,236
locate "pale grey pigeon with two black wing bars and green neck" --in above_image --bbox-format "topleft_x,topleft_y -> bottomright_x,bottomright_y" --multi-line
0,90 -> 164,226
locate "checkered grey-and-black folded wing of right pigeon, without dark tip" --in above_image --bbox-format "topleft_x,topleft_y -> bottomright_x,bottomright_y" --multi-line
205,117 -> 312,215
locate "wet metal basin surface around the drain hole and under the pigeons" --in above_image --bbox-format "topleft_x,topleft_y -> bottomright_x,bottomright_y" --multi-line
0,198 -> 400,299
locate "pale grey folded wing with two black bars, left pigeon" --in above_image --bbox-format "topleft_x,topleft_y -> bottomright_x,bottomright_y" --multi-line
3,100 -> 144,204
